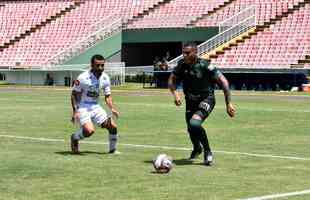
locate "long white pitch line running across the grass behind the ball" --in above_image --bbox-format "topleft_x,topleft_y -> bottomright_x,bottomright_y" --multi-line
0,135 -> 310,161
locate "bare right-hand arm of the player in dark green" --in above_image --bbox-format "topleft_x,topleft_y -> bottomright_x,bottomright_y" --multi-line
217,74 -> 236,117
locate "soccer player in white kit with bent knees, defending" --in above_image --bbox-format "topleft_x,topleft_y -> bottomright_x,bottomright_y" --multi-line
71,55 -> 119,153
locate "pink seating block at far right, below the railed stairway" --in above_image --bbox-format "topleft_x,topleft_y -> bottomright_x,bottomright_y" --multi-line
212,4 -> 310,69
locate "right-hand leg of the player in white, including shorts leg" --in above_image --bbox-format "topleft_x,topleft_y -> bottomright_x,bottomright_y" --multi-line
93,106 -> 118,153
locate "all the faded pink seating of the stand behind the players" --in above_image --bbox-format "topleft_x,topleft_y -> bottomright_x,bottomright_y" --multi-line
0,0 -> 310,71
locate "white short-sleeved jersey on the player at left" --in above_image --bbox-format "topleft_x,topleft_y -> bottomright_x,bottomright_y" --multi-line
72,70 -> 111,107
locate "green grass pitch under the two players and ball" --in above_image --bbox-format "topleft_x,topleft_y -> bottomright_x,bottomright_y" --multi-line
0,85 -> 310,200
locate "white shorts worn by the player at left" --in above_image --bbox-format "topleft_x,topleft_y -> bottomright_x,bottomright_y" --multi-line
78,104 -> 108,126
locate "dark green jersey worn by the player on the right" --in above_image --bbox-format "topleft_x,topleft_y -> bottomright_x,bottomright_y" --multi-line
172,58 -> 221,99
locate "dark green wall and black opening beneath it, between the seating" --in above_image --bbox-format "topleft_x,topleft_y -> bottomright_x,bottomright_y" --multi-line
122,27 -> 218,66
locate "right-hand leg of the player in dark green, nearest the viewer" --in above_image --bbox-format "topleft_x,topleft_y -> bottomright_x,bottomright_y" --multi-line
189,97 -> 215,165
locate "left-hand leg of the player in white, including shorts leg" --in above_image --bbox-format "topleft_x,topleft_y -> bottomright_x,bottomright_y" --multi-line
71,109 -> 95,153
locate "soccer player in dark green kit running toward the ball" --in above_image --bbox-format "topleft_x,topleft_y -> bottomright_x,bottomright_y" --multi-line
168,43 -> 236,166
